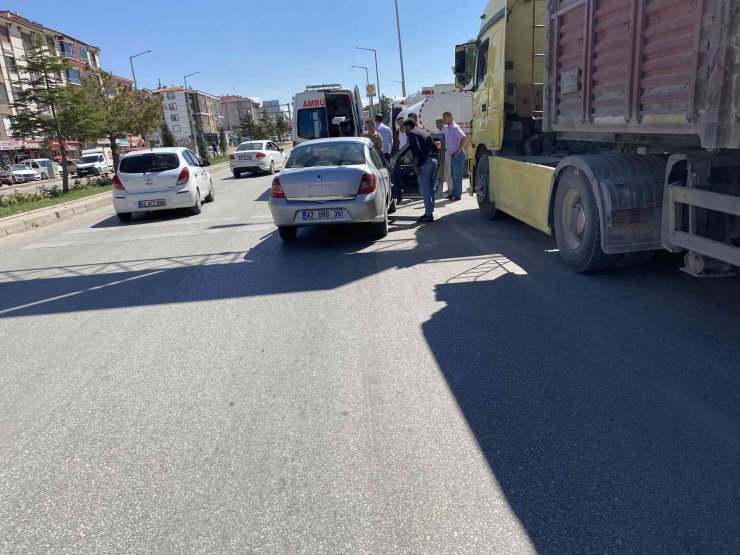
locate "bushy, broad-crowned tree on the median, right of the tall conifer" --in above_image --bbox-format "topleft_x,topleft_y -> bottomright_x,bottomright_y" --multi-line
82,71 -> 163,172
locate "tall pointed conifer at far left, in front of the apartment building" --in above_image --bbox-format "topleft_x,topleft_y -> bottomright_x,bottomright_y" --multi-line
12,36 -> 99,193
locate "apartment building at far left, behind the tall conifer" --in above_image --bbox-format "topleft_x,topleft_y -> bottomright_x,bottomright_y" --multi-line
0,10 -> 100,165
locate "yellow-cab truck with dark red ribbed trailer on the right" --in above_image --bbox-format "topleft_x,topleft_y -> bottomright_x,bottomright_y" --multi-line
455,0 -> 740,276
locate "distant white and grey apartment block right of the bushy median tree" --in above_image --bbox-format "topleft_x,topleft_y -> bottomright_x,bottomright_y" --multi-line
151,86 -> 223,149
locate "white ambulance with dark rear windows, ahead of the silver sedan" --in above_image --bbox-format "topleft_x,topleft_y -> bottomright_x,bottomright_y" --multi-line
293,84 -> 365,145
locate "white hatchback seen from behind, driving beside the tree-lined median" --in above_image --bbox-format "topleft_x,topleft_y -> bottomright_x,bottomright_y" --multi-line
113,147 -> 215,222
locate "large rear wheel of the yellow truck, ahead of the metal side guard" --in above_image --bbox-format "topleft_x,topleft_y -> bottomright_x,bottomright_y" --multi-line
555,169 -> 620,273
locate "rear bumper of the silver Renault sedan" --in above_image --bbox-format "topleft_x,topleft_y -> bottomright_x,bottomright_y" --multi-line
269,192 -> 385,227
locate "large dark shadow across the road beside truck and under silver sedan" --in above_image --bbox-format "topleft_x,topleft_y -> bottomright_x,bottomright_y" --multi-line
0,206 -> 740,553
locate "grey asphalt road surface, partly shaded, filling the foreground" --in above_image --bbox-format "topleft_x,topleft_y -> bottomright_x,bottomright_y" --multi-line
0,163 -> 740,554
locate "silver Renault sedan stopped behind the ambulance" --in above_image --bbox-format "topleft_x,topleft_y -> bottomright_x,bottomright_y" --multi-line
270,137 -> 395,241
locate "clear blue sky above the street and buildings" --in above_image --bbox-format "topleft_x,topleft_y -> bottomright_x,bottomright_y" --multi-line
8,0 -> 486,102
